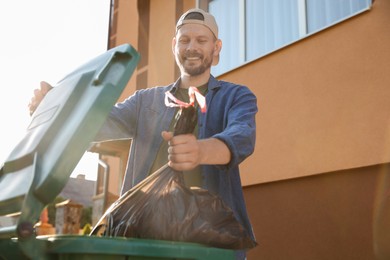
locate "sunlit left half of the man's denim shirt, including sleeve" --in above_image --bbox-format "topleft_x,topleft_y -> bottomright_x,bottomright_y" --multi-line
95,85 -> 175,189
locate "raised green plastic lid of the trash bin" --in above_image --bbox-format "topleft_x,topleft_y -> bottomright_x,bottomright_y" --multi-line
0,44 -> 139,228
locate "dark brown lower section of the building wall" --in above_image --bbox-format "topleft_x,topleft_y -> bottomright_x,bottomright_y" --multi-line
244,164 -> 390,260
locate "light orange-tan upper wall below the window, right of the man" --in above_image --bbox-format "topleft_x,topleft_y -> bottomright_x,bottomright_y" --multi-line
220,0 -> 390,185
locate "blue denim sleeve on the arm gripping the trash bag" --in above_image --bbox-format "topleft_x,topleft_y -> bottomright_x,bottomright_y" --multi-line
206,82 -> 258,170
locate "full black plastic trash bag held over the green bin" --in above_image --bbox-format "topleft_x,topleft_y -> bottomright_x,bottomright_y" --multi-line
91,107 -> 257,250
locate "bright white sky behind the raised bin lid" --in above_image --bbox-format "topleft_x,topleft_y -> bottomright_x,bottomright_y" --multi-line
0,0 -> 110,179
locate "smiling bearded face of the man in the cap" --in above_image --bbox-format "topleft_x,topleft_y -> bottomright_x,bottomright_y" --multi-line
172,24 -> 219,76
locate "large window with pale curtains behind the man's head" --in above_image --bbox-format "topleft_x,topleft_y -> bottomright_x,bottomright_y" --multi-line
206,0 -> 371,76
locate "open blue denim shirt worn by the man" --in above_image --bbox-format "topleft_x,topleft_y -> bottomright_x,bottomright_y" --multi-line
97,76 -> 258,244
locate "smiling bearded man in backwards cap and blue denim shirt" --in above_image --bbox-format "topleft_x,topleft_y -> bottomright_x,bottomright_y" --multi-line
30,9 -> 258,259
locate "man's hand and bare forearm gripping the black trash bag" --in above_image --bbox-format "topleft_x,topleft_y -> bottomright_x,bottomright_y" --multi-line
161,131 -> 231,171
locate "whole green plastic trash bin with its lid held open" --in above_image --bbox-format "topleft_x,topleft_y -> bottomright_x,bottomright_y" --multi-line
0,44 -> 234,260
